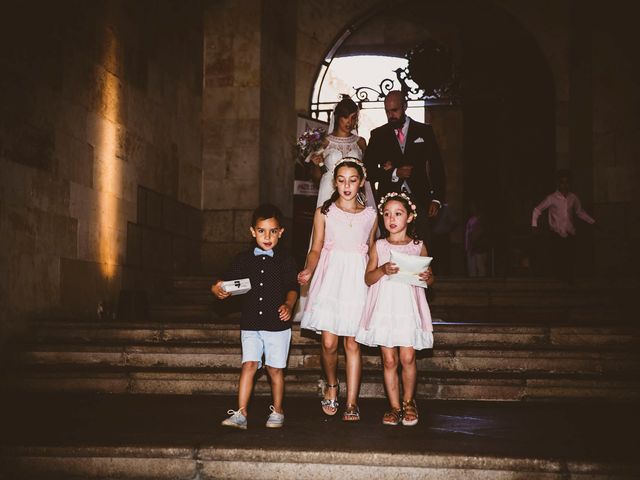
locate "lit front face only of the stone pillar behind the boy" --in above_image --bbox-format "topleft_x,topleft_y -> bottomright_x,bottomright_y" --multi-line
202,0 -> 262,272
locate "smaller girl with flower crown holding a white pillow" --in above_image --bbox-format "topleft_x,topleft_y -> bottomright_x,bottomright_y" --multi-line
356,192 -> 433,426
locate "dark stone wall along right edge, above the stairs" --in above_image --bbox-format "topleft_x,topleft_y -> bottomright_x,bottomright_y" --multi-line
589,3 -> 640,277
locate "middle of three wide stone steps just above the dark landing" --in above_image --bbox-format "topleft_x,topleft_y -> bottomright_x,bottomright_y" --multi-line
19,344 -> 640,375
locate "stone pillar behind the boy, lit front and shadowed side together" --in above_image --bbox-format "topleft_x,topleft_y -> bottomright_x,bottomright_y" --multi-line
202,0 -> 297,273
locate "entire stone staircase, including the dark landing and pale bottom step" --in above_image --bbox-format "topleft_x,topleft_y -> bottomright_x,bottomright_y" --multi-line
5,277 -> 640,480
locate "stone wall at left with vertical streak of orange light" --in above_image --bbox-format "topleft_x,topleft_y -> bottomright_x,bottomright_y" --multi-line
0,0 -> 202,336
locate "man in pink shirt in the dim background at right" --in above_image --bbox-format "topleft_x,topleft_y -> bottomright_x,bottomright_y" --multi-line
531,170 -> 596,282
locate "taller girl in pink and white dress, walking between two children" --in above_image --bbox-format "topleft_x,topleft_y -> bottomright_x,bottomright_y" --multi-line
298,157 -> 377,421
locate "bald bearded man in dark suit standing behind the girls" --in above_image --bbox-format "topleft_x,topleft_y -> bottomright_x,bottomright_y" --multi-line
364,90 -> 446,242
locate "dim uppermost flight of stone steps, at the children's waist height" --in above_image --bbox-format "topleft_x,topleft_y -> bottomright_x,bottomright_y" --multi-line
152,276 -> 640,325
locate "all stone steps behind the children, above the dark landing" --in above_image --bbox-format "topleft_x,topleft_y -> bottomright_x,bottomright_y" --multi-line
8,277 -> 640,400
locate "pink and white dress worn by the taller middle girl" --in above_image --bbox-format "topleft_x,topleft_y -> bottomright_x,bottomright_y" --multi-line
300,203 -> 377,337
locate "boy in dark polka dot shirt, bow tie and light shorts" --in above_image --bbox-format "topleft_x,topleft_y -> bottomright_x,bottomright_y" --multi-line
211,204 -> 299,430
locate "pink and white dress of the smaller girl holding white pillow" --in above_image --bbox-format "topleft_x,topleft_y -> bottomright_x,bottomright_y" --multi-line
356,238 -> 433,350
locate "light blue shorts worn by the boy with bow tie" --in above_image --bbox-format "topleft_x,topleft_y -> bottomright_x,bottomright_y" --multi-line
240,328 -> 291,368
